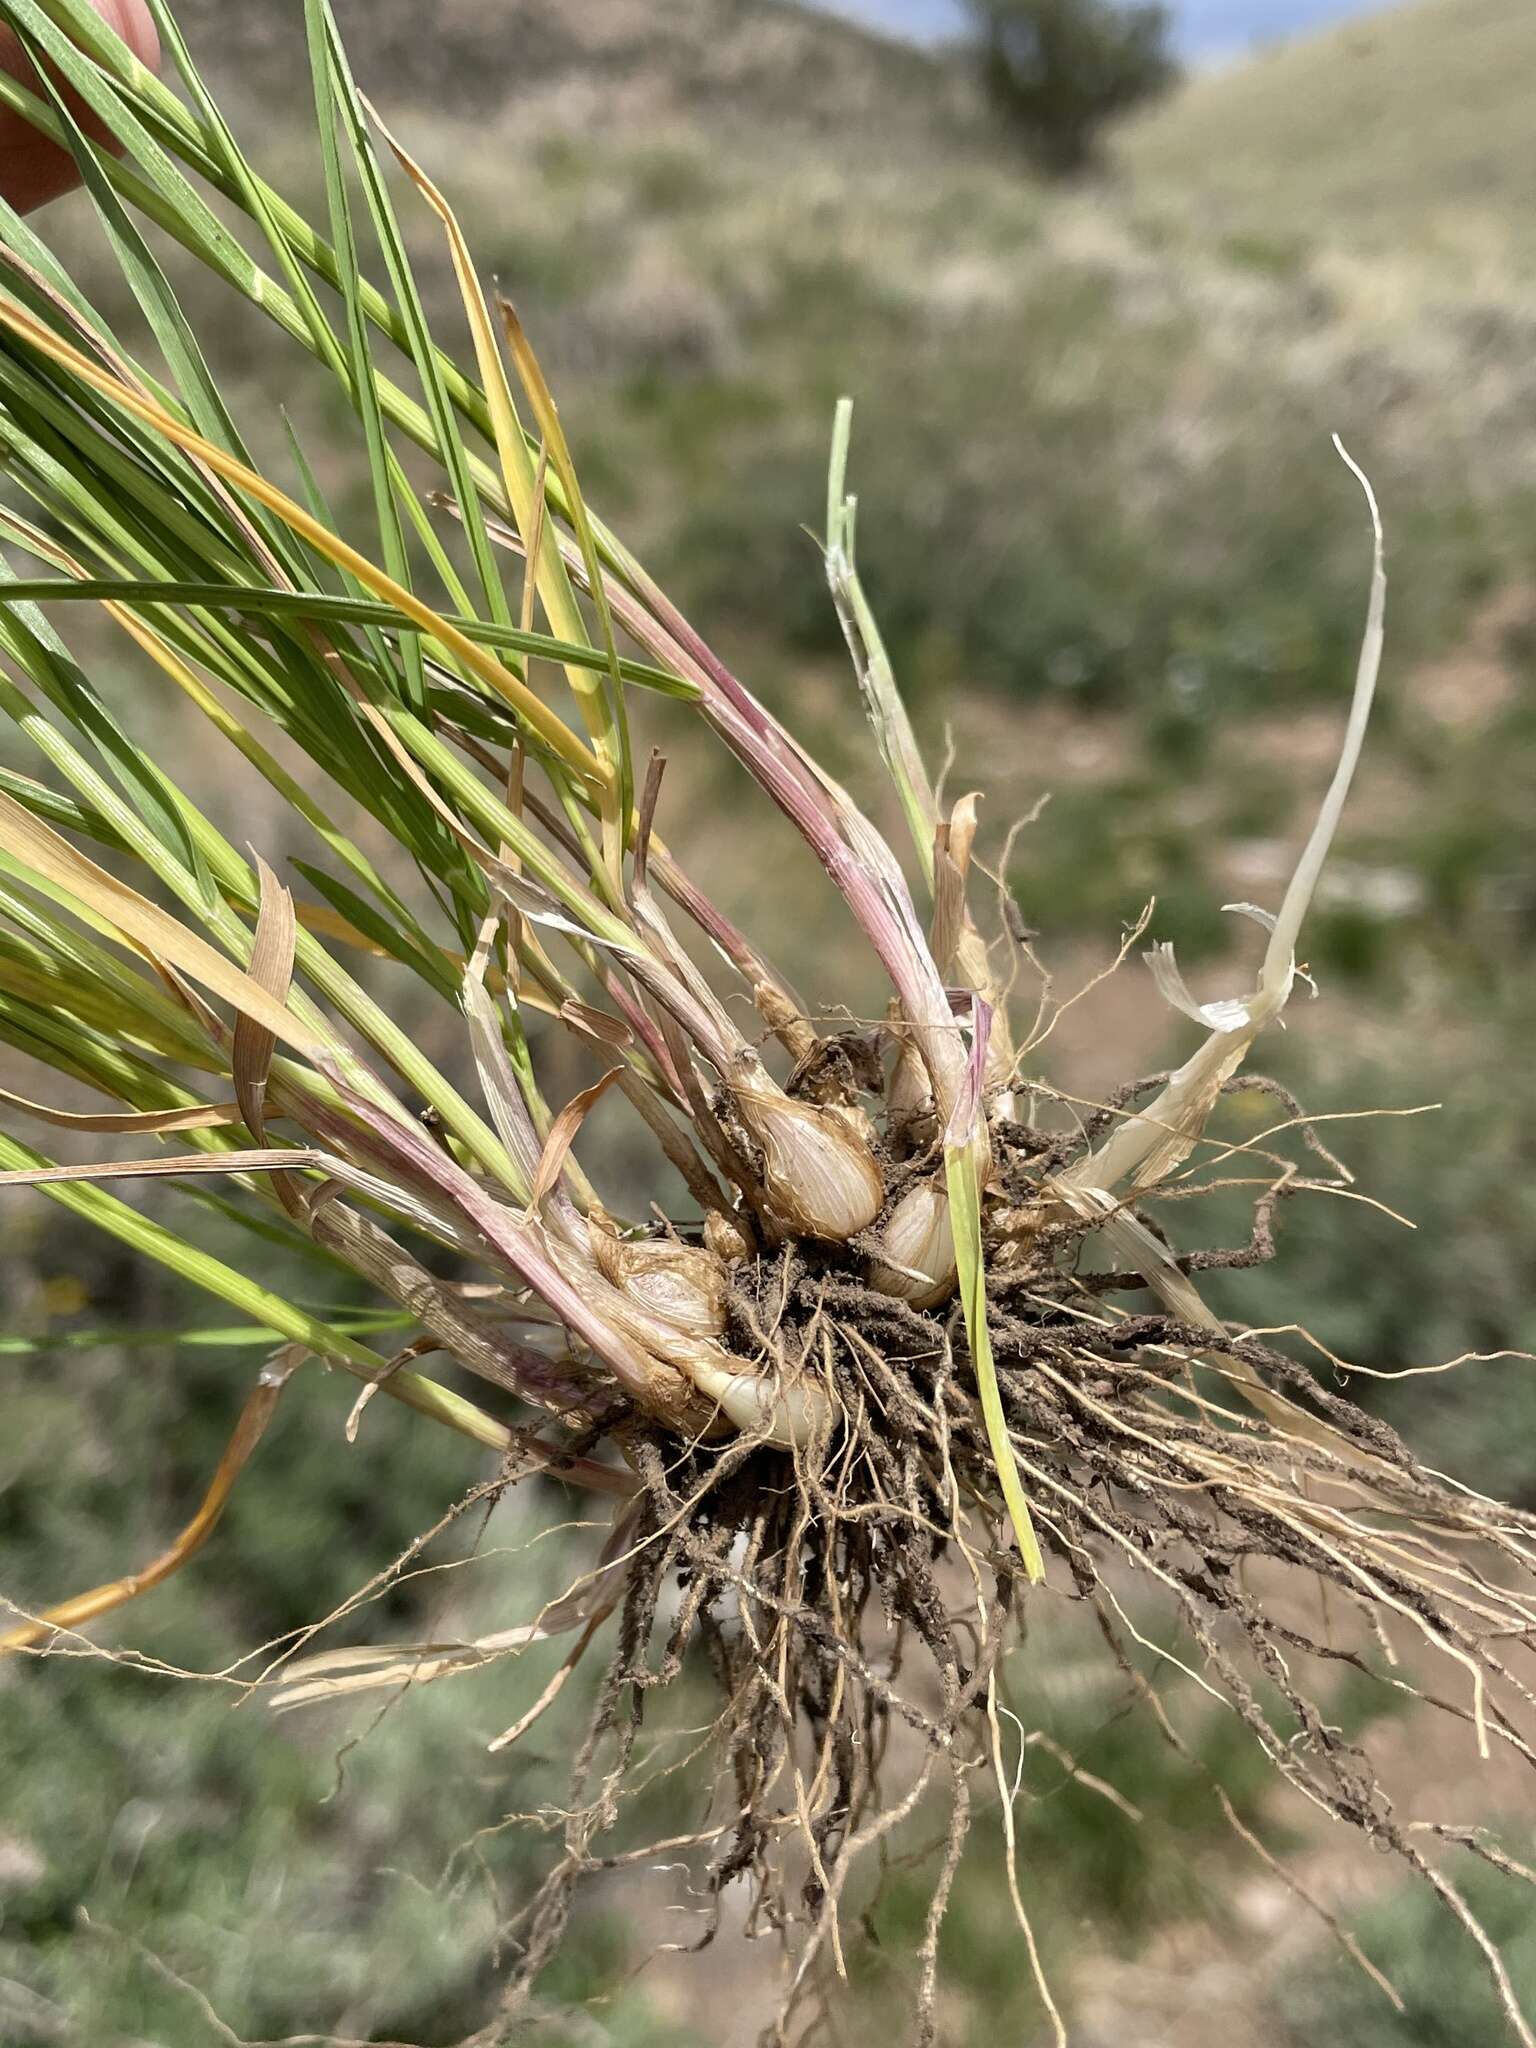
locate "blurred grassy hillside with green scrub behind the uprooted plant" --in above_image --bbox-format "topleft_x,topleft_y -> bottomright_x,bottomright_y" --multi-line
0,0 -> 1536,2048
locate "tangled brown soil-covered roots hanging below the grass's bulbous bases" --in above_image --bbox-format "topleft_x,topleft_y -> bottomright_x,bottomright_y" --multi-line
456,1083 -> 1536,2042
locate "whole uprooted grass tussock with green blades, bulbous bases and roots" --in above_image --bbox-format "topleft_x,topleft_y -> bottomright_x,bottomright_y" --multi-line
0,0 -> 1536,2044
